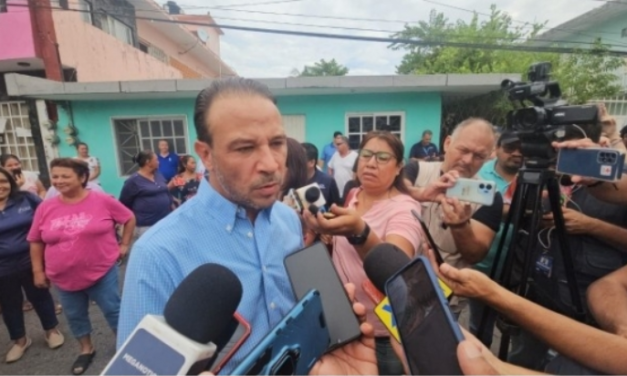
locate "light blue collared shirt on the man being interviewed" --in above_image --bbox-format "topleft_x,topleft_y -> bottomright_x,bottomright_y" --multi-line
117,179 -> 303,374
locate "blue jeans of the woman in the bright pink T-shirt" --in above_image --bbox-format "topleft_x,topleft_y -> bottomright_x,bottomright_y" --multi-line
58,265 -> 120,338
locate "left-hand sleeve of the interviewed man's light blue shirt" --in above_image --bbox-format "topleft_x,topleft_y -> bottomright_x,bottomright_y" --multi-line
116,243 -> 180,350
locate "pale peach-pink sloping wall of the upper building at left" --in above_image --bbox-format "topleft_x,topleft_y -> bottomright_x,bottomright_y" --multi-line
53,1 -> 182,82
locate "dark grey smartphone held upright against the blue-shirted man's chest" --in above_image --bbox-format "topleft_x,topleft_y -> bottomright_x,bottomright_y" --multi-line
284,242 -> 361,351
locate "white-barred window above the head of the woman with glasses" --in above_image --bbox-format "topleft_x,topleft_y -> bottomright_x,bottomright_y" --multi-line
346,112 -> 405,150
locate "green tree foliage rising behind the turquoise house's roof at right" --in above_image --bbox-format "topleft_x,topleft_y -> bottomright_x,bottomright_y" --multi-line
390,5 -> 624,104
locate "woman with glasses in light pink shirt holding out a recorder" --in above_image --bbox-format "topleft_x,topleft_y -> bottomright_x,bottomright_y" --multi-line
305,132 -> 421,375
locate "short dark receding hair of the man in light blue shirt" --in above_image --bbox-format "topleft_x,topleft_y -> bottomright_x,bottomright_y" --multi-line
194,77 -> 276,145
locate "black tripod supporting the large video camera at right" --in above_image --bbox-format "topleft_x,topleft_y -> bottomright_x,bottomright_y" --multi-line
477,161 -> 583,360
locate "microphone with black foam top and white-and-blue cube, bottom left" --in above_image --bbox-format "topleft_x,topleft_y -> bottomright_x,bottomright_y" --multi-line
102,264 -> 242,375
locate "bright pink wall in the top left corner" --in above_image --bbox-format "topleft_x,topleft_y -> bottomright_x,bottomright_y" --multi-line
0,0 -> 37,60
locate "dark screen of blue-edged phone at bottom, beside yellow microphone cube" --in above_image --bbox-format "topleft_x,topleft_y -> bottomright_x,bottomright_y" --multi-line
386,256 -> 463,375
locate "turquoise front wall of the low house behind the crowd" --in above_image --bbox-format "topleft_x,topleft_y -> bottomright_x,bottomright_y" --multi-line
59,93 -> 441,196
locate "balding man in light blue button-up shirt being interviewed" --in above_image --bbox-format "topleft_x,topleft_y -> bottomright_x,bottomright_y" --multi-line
117,78 -> 303,374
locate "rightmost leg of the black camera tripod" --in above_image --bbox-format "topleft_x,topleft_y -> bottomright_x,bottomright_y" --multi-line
548,177 -> 584,315
